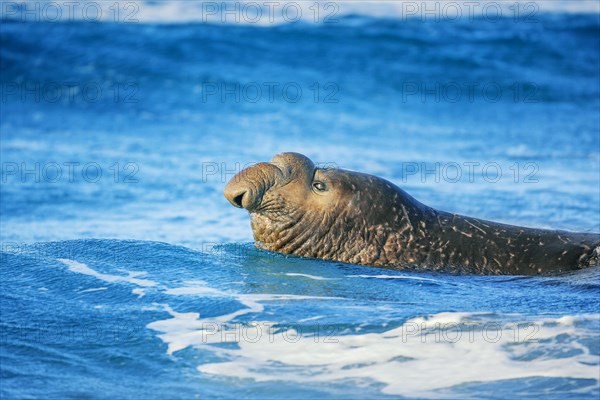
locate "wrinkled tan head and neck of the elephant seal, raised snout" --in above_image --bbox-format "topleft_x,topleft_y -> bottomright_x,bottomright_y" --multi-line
225,153 -> 420,264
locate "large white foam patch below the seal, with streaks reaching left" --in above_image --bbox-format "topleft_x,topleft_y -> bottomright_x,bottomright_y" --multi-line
147,276 -> 600,397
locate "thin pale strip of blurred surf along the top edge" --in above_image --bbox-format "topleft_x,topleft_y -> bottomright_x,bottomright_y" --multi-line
5,0 -> 600,26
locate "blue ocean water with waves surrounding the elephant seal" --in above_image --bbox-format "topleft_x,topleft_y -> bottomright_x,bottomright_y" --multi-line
0,2 -> 600,399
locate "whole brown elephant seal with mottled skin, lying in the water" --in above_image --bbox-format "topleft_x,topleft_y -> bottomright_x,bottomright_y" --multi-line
225,153 -> 600,275
